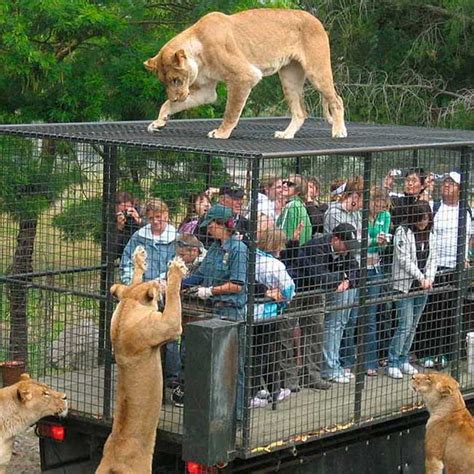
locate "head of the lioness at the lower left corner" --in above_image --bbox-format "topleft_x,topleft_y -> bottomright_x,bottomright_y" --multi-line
16,374 -> 68,420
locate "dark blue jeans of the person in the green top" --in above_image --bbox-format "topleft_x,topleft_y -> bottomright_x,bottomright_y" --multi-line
364,268 -> 384,370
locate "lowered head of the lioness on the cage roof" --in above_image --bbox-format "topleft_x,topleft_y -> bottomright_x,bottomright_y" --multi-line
143,48 -> 193,102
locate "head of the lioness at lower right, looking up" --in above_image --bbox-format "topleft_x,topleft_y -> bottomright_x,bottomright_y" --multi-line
411,372 -> 464,412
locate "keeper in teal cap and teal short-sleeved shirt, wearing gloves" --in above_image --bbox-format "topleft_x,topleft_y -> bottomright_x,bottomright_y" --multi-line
183,204 -> 248,420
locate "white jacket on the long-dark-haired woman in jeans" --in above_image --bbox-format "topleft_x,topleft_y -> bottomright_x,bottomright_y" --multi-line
392,226 -> 438,293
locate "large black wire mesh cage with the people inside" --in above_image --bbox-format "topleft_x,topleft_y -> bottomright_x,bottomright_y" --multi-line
0,120 -> 474,456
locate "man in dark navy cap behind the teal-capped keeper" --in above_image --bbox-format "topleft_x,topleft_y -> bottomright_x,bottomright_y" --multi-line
194,182 -> 249,248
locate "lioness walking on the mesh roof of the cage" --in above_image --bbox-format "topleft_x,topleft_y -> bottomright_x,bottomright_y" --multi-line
144,8 -> 347,138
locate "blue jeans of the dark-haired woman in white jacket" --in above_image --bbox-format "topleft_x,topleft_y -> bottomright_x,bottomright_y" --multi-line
388,295 -> 428,368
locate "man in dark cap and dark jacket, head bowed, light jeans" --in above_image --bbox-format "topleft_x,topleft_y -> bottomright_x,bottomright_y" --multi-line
286,223 -> 360,389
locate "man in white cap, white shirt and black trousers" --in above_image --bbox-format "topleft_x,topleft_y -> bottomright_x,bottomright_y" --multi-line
417,171 -> 472,368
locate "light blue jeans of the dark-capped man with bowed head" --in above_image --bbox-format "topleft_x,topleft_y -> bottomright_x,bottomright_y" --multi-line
321,289 -> 357,379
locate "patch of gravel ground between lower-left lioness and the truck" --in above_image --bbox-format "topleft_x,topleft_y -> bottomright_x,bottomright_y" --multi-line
7,427 -> 41,474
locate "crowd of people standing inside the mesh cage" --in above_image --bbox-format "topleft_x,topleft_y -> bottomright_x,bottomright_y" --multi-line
114,168 -> 473,412
